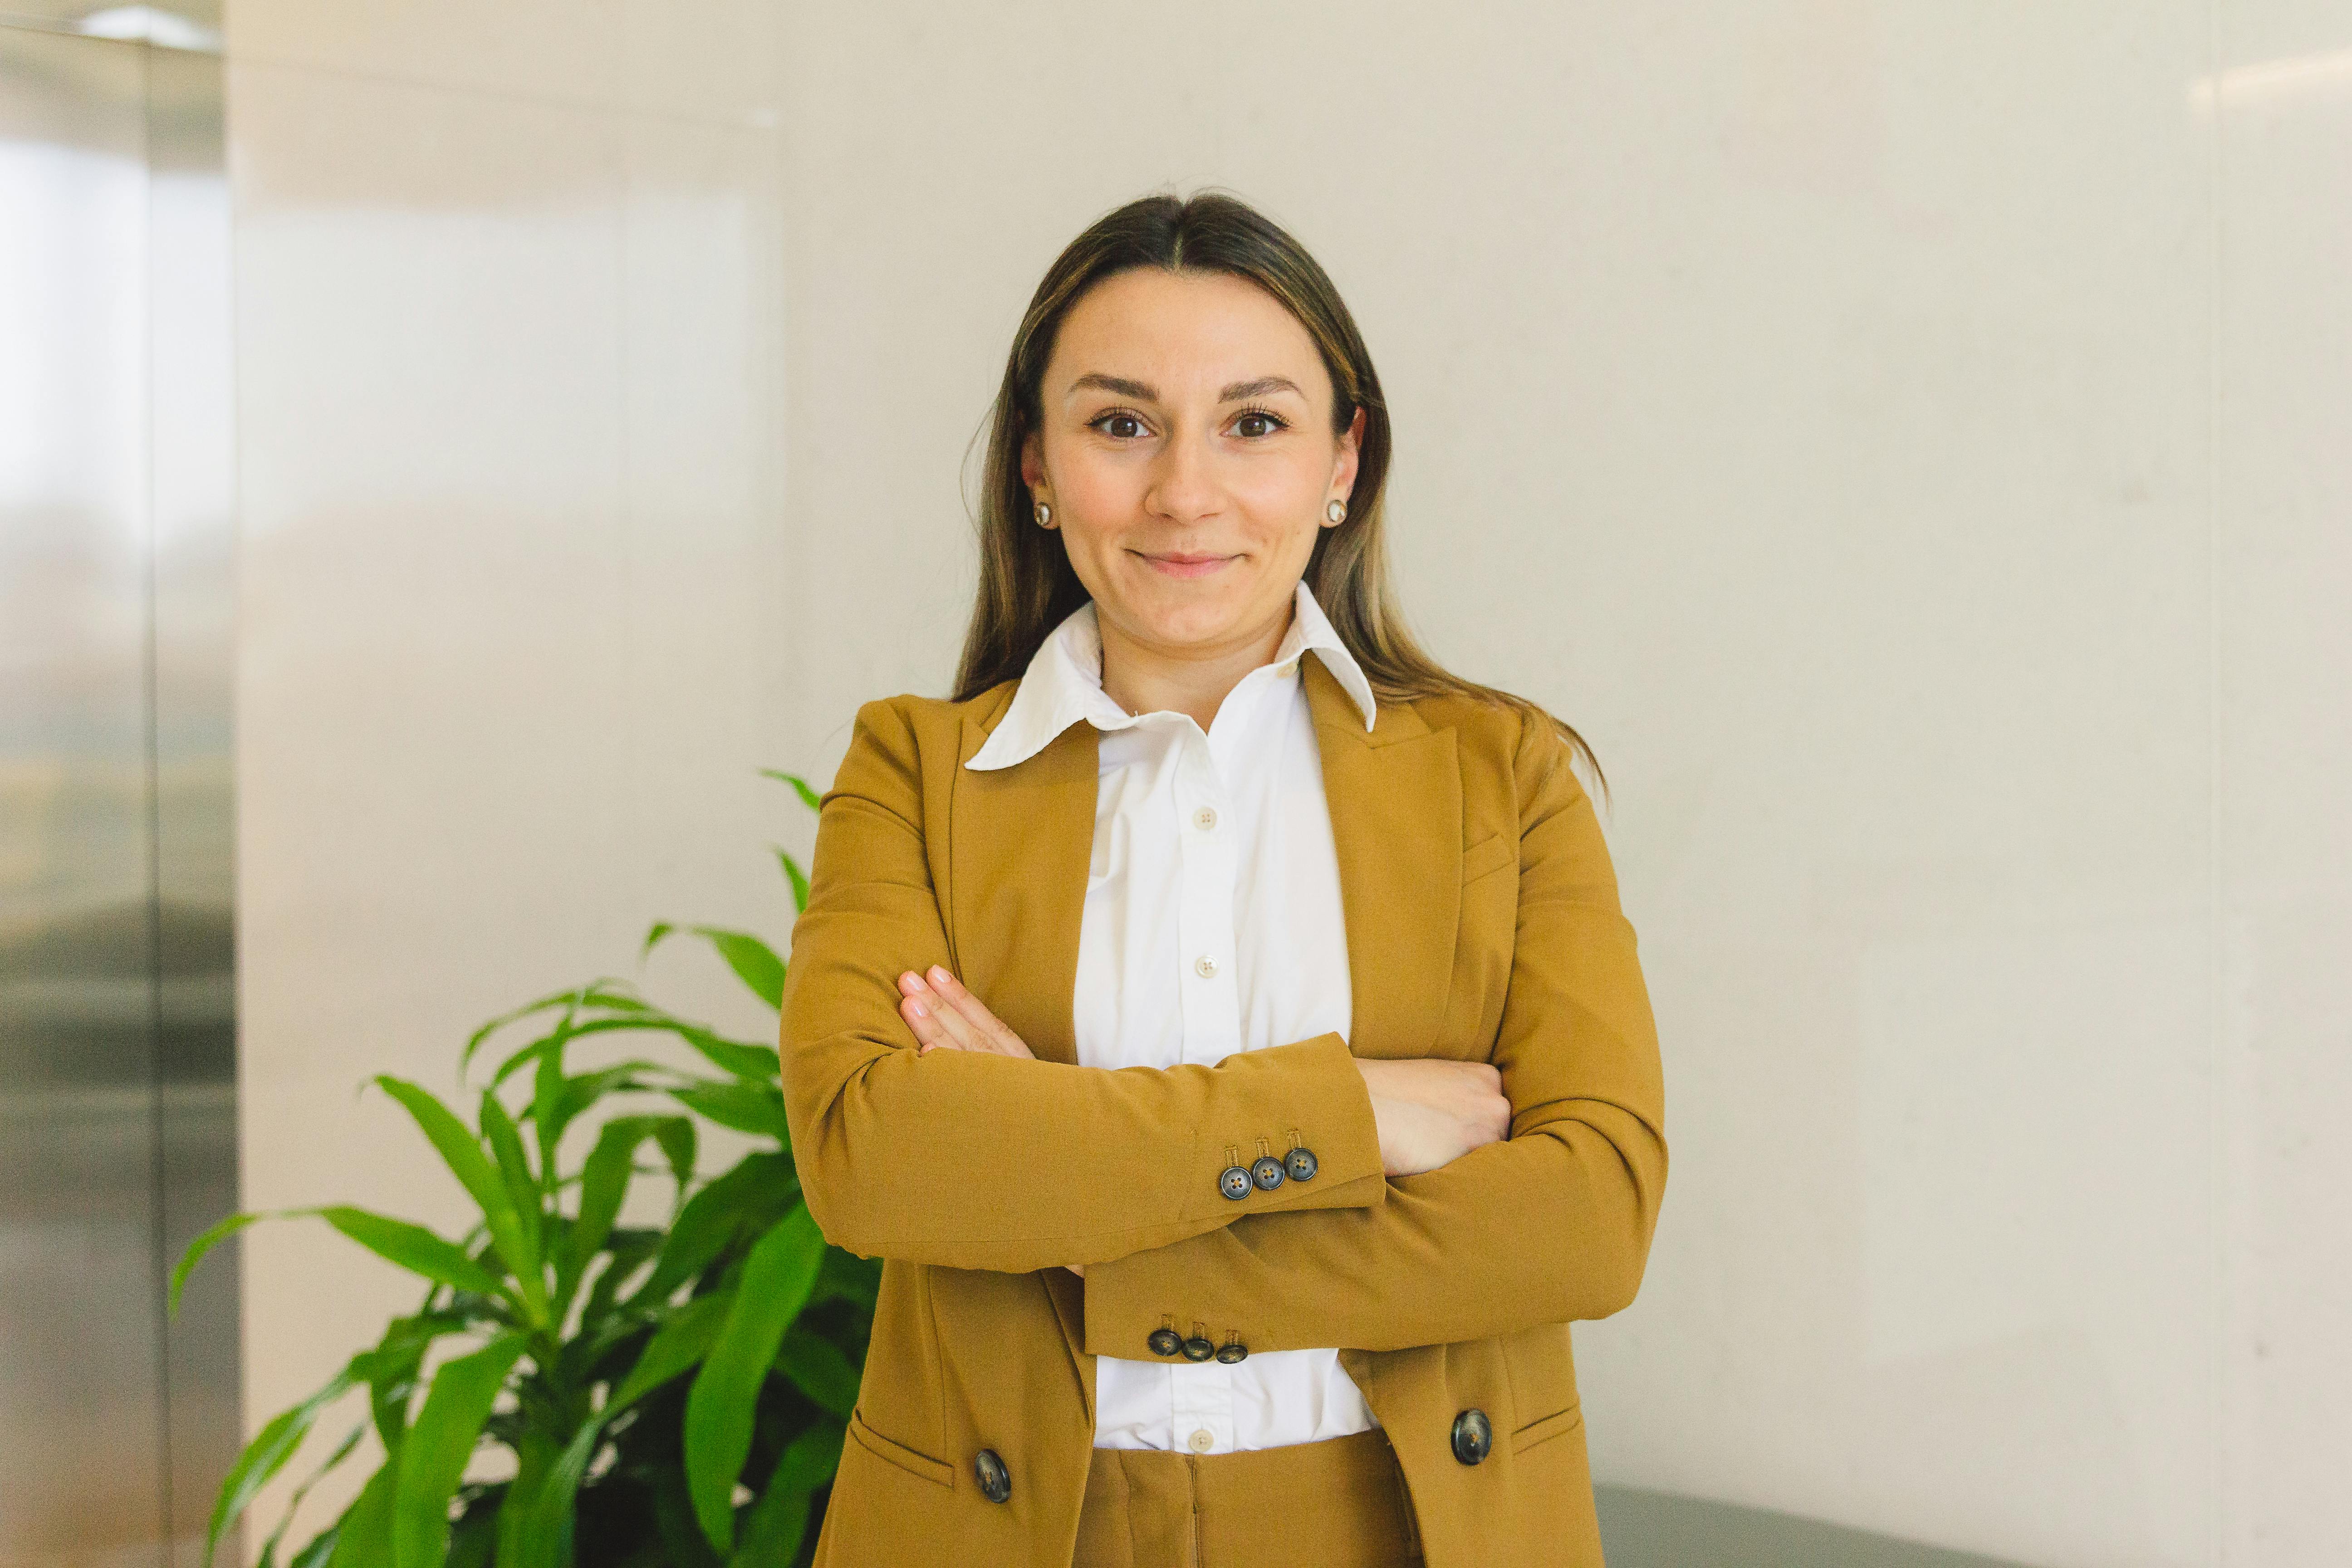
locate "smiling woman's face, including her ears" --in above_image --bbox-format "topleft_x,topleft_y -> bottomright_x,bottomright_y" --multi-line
1021,268 -> 1364,656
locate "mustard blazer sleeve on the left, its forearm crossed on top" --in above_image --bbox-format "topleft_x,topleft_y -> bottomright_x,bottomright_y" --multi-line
779,703 -> 1388,1272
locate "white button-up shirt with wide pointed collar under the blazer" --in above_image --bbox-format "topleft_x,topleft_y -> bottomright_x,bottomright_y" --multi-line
964,583 -> 1378,1453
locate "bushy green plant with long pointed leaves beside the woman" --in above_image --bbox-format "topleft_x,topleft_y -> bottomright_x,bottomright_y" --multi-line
172,771 -> 880,1568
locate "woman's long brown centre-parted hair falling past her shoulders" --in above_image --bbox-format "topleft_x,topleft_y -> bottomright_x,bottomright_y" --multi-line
955,191 -> 1607,790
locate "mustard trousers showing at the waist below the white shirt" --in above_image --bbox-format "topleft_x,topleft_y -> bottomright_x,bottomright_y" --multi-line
1070,1427 -> 1421,1568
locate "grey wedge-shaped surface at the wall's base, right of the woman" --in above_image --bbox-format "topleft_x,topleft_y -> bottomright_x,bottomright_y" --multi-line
1592,1486 -> 2020,1568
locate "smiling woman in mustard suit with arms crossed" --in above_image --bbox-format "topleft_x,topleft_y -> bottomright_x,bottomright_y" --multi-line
783,195 -> 1665,1568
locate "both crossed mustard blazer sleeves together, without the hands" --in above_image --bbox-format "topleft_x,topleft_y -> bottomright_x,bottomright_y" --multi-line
783,708 -> 1665,1357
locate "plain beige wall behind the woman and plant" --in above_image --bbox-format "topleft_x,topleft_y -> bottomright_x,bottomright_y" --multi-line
228,0 -> 2352,1568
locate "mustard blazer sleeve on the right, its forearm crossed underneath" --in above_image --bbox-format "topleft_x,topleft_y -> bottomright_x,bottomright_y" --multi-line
1084,724 -> 1665,1357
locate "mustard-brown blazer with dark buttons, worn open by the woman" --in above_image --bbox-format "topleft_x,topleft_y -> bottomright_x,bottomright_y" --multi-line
781,656 -> 1665,1568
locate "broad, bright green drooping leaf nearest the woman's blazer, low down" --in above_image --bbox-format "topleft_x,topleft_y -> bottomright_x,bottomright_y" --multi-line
685,1204 -> 826,1554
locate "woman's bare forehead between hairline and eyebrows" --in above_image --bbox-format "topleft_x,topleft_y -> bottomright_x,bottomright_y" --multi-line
1047,268 -> 1331,402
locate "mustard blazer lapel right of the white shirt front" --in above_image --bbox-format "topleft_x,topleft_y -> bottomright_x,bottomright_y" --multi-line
1301,653 -> 1463,1058
